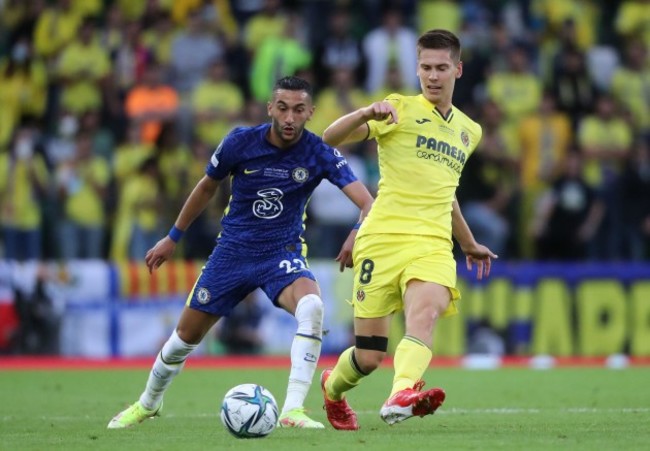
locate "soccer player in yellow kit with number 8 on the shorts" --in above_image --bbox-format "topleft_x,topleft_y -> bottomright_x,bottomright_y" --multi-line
321,30 -> 497,430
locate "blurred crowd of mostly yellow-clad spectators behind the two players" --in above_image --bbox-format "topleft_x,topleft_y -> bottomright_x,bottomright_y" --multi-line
0,0 -> 650,261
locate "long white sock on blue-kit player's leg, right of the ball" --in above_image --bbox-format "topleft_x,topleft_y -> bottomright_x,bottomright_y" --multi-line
282,294 -> 323,413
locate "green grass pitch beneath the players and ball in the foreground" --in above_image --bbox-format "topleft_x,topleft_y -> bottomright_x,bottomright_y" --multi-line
0,367 -> 650,451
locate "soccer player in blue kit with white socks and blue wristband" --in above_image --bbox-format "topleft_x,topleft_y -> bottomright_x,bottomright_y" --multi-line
108,77 -> 373,429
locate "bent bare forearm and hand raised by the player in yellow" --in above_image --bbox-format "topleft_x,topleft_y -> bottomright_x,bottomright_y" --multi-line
323,101 -> 397,146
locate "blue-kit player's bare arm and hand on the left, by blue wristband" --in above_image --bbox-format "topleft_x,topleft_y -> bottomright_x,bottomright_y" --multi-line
144,175 -> 220,273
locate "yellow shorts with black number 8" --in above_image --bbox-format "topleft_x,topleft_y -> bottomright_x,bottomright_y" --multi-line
352,234 -> 460,318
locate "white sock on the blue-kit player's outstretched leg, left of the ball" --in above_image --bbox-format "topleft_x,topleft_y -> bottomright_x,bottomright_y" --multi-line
140,330 -> 198,410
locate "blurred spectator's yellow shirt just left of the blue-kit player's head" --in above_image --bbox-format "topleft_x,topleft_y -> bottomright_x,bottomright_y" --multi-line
192,80 -> 244,146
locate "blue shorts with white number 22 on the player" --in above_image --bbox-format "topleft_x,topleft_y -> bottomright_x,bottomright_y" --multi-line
185,246 -> 316,316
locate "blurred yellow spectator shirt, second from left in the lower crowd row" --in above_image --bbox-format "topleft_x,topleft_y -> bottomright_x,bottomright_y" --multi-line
65,157 -> 110,227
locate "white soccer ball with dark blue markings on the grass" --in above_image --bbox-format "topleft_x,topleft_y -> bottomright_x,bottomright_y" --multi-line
221,384 -> 278,438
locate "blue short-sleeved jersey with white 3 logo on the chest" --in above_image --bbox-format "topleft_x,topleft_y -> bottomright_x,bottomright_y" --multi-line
206,124 -> 357,255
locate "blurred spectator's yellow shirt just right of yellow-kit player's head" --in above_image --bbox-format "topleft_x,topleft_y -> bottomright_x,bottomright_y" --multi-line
487,72 -> 542,122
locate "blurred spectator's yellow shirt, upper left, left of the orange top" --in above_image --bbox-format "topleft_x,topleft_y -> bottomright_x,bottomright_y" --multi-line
58,41 -> 110,113
